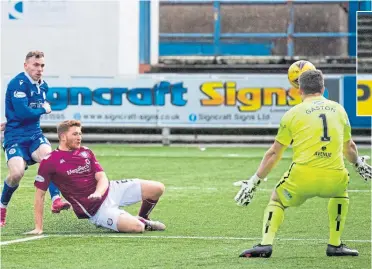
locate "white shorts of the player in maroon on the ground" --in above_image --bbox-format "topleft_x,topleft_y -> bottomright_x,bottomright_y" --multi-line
89,178 -> 142,232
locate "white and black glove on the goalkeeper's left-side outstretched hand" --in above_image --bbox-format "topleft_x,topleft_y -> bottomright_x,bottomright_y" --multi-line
234,174 -> 262,206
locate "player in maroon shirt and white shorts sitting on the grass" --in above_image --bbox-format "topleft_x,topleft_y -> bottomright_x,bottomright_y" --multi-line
28,120 -> 165,234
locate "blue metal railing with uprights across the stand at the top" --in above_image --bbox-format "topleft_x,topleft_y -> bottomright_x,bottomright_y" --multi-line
160,0 -> 371,56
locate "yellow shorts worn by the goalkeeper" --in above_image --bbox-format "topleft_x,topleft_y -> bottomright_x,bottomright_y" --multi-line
276,163 -> 349,207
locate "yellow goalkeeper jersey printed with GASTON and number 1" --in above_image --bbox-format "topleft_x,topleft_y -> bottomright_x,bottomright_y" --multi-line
275,96 -> 351,169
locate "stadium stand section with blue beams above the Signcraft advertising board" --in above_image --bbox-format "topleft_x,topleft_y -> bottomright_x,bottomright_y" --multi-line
151,0 -> 361,73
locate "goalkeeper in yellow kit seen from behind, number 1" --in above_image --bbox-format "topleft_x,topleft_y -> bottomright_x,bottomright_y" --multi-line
235,70 -> 372,258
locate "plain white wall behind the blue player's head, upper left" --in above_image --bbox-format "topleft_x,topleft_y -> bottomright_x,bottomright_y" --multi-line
0,0 -> 145,120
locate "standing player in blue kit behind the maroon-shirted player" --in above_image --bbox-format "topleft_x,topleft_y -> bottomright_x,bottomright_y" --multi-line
0,51 -> 70,227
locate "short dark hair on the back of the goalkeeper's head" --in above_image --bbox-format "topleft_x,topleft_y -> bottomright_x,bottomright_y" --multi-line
298,70 -> 324,94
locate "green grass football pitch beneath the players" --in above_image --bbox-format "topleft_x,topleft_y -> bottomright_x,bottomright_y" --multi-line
1,144 -> 371,269
